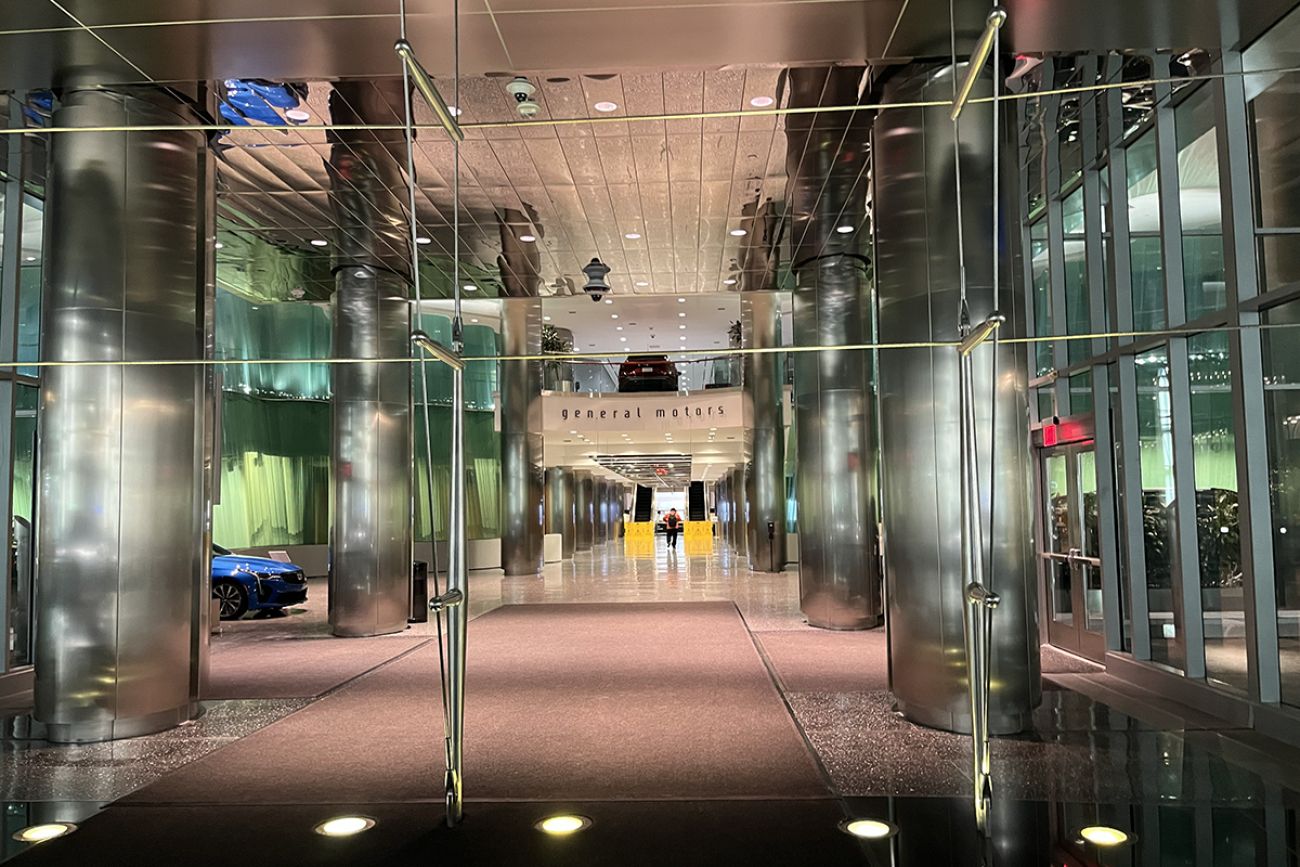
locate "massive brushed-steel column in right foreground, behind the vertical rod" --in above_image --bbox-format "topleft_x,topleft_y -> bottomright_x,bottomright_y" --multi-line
878,65 -> 1040,733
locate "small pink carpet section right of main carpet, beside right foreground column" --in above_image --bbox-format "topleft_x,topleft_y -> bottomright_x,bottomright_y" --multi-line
755,628 -> 889,693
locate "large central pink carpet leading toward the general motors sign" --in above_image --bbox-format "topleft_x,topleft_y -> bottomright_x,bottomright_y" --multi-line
129,603 -> 828,803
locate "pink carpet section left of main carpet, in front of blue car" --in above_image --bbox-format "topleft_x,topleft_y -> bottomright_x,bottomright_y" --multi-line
203,637 -> 428,699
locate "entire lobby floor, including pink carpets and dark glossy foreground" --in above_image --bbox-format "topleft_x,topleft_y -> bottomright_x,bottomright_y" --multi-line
0,541 -> 1300,866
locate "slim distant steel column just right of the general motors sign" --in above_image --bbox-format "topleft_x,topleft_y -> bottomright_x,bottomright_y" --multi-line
741,291 -> 785,572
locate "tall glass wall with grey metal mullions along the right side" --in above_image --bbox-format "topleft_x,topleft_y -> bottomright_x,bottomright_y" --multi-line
1019,20 -> 1300,721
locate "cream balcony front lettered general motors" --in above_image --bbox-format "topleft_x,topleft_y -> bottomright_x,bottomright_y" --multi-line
542,389 -> 744,433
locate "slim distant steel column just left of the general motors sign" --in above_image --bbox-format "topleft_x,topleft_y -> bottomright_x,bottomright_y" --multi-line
501,296 -> 545,576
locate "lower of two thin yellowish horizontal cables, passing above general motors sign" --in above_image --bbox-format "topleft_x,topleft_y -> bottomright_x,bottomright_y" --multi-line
0,322 -> 1300,370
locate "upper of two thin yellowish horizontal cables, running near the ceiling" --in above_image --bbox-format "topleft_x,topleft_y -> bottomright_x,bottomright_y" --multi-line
0,66 -> 1300,135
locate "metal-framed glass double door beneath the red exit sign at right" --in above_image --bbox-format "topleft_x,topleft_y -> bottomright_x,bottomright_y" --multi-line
1039,442 -> 1106,659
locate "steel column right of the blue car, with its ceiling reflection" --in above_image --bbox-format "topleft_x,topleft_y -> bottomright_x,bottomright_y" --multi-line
328,79 -> 412,636
